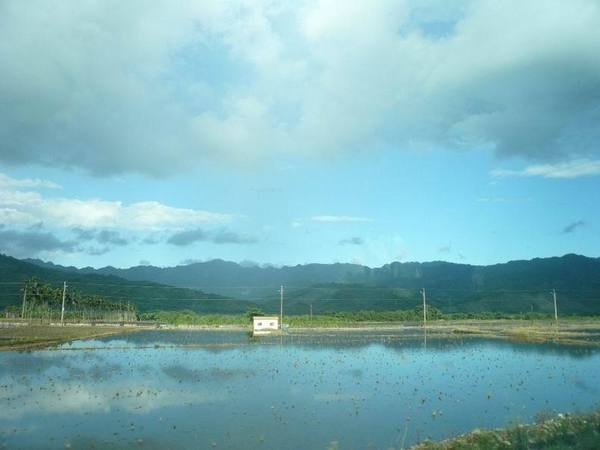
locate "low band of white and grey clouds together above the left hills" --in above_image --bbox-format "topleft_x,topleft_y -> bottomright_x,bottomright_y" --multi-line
0,173 -> 244,257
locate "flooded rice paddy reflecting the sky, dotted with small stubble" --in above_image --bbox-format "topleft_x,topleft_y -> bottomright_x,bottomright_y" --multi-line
0,331 -> 600,450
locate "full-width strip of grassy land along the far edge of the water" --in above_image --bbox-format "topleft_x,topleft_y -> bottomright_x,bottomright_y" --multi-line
0,311 -> 600,349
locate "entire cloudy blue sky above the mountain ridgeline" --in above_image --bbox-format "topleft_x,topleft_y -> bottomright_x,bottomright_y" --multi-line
0,0 -> 600,267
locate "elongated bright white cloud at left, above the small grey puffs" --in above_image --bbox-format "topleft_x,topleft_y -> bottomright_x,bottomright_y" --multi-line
0,180 -> 233,230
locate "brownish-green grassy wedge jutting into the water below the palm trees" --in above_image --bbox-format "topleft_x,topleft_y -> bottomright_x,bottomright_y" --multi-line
0,325 -> 133,350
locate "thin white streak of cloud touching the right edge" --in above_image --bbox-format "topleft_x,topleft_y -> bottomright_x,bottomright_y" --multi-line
491,159 -> 600,178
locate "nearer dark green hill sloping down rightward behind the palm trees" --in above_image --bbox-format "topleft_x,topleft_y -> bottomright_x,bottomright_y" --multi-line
0,254 -> 255,313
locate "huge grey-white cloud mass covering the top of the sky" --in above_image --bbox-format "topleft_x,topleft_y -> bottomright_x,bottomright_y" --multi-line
0,0 -> 600,176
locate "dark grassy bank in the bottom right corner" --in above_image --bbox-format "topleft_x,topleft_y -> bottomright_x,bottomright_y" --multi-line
412,412 -> 600,450
